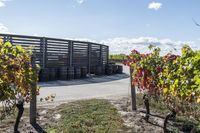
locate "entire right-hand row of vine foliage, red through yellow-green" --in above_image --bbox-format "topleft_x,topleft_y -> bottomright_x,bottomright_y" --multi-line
124,45 -> 200,124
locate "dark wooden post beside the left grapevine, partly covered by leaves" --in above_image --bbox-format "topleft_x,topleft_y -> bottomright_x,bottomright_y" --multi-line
29,54 -> 37,125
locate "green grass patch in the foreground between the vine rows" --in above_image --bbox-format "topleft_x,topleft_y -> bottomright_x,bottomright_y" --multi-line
47,99 -> 123,133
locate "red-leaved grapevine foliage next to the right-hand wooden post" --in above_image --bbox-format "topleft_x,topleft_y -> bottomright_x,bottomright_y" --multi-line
125,45 -> 163,97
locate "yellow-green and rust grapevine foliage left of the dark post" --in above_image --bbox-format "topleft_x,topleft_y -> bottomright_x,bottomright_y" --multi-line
0,40 -> 39,119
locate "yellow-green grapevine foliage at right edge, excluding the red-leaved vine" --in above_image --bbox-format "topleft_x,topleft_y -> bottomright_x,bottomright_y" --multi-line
159,45 -> 200,119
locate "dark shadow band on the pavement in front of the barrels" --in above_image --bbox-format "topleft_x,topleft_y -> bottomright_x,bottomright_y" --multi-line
39,73 -> 129,87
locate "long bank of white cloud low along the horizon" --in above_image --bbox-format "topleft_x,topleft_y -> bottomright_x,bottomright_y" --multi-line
100,37 -> 197,54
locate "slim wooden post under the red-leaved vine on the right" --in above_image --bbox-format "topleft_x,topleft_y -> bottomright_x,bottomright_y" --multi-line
130,66 -> 137,111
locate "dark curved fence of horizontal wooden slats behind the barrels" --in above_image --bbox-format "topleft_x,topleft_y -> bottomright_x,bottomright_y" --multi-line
0,34 -> 109,73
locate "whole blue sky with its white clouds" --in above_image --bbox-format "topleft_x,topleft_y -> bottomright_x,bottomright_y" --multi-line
0,0 -> 200,54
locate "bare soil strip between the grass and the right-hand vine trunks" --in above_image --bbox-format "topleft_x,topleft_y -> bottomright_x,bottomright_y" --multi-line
110,97 -> 164,133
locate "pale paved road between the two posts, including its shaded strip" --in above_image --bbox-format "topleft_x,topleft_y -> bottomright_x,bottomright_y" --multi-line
38,66 -> 130,106
